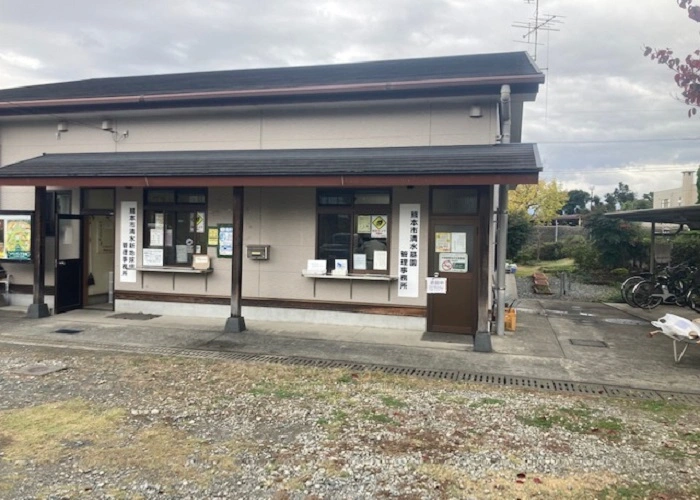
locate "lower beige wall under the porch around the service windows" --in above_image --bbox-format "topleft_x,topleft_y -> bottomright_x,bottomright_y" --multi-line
110,187 -> 429,305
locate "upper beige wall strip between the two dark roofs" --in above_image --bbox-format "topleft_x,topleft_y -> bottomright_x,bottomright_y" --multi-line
0,101 -> 497,166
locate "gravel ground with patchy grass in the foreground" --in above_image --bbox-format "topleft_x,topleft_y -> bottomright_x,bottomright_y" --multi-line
0,344 -> 700,500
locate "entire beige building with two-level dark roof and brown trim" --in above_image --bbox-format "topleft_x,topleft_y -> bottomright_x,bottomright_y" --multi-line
0,53 -> 543,348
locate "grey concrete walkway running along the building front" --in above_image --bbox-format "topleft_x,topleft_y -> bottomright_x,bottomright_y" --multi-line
0,300 -> 700,393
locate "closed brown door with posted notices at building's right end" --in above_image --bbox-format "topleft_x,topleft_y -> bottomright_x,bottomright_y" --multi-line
428,216 -> 479,334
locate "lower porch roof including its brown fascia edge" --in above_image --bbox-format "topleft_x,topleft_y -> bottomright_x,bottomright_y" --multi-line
0,144 -> 542,187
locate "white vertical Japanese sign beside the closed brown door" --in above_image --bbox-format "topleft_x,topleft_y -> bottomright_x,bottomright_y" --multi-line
398,203 -> 420,297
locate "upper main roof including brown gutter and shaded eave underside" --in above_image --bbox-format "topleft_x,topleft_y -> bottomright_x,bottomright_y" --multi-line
0,52 -> 544,117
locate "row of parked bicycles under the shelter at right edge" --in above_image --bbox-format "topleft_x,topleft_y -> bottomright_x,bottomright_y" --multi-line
620,264 -> 700,312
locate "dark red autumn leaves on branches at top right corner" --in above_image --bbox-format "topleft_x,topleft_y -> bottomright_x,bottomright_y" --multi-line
644,0 -> 700,117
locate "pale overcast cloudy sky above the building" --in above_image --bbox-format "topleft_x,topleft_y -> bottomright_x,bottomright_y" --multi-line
0,0 -> 700,199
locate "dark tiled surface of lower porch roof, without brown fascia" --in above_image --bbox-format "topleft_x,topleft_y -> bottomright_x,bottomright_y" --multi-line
0,144 -> 541,179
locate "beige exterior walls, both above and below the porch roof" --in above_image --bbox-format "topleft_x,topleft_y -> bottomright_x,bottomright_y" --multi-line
0,100 -> 498,320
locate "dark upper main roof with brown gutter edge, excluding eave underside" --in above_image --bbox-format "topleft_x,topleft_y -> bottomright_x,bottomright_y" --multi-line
0,52 -> 544,102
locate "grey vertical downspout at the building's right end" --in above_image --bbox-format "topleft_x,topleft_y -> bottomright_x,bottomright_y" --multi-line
496,85 -> 511,335
